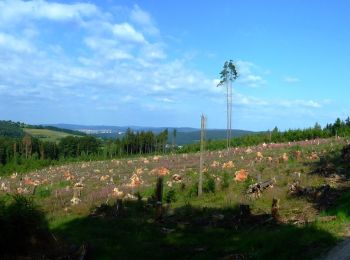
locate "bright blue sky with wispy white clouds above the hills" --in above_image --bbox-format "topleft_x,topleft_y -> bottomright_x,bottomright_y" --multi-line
0,0 -> 350,130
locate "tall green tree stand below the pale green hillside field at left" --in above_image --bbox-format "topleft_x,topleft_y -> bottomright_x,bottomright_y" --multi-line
0,129 -> 168,173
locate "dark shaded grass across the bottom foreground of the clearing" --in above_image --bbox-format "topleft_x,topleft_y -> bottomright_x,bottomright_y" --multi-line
53,200 -> 338,259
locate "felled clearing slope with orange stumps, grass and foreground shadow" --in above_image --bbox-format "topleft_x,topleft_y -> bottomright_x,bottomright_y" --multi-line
0,138 -> 350,259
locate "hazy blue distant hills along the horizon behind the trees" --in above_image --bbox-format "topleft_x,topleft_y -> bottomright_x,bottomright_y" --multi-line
45,124 -> 257,145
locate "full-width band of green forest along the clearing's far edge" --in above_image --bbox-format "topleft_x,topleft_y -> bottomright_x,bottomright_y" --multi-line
0,118 -> 350,174
